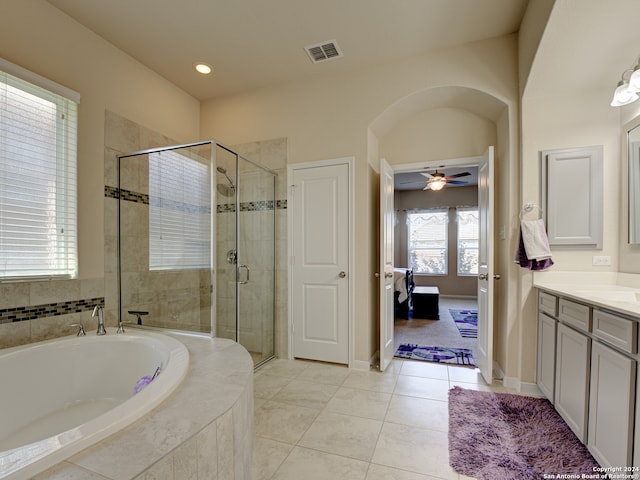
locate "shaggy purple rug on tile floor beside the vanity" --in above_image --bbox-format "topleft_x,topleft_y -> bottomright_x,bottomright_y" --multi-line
449,387 -> 598,480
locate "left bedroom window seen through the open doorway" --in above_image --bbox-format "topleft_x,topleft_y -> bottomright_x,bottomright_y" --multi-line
407,209 -> 449,275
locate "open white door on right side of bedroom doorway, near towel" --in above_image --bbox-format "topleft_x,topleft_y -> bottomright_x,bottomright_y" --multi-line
476,147 -> 494,383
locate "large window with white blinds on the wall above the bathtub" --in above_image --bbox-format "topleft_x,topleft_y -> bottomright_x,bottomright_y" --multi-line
0,59 -> 80,283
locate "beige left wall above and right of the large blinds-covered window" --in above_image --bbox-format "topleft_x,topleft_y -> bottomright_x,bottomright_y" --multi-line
0,0 -> 200,278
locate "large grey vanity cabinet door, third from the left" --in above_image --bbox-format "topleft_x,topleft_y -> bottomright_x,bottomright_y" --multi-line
587,342 -> 636,467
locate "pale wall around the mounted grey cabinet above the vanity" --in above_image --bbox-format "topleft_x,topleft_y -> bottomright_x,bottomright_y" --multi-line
516,89 -> 621,382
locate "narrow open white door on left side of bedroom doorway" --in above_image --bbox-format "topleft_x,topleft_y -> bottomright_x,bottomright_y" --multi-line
379,159 -> 395,372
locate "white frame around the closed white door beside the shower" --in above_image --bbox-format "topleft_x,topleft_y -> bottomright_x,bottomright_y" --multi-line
286,157 -> 356,368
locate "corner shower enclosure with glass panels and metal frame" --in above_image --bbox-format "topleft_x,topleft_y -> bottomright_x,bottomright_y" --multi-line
118,141 -> 276,366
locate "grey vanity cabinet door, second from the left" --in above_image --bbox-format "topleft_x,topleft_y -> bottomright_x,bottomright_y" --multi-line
555,323 -> 591,443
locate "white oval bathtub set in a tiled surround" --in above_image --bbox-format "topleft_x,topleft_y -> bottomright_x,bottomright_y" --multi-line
0,329 -> 189,479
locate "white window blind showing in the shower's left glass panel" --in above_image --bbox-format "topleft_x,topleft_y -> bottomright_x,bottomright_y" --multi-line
149,150 -> 211,270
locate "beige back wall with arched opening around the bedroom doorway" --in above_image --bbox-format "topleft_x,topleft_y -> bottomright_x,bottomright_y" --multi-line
201,35 -> 518,361
